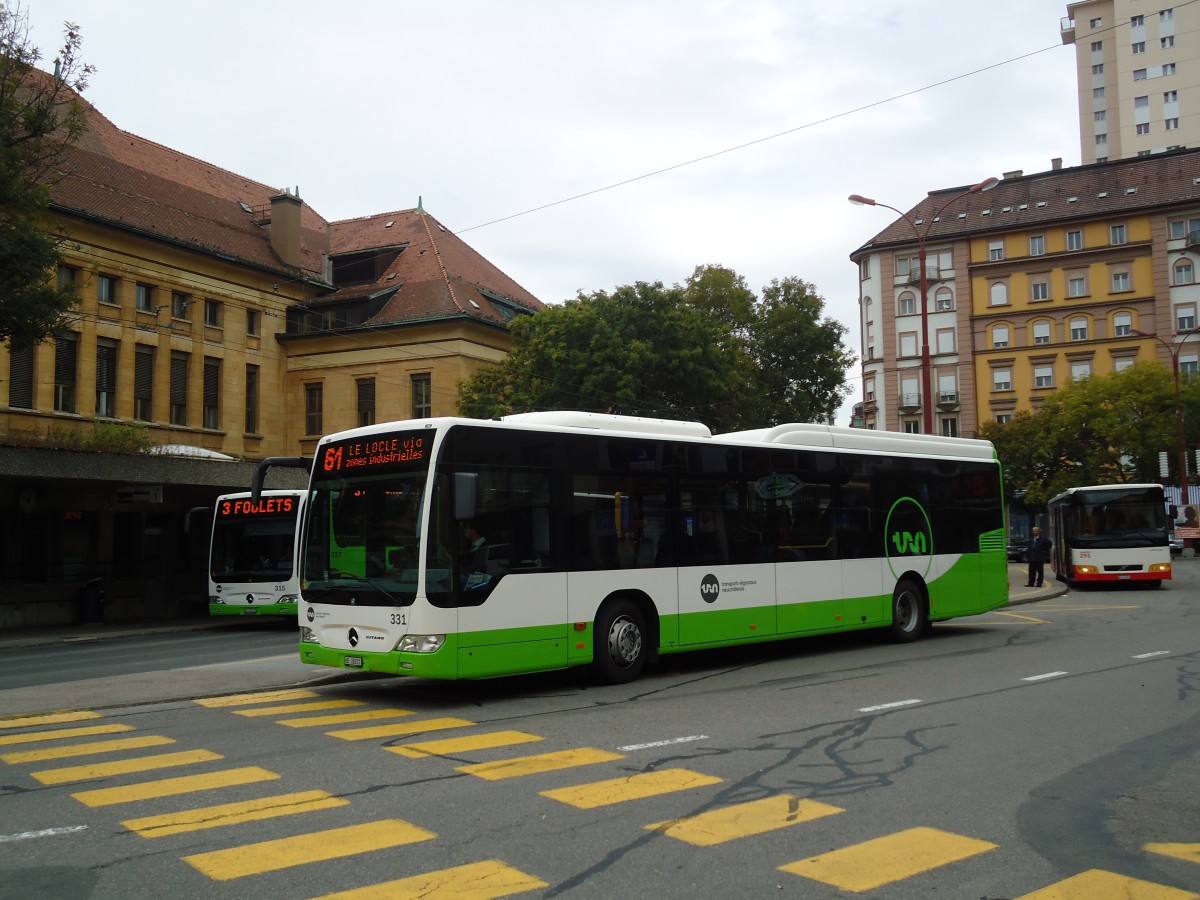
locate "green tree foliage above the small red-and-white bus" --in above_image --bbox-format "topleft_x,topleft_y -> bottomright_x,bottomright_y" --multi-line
979,362 -> 1200,509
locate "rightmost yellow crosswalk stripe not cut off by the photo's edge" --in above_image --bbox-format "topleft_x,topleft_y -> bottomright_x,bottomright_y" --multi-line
779,828 -> 996,892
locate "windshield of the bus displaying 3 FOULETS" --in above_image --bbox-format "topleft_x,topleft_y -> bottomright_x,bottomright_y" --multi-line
210,498 -> 299,584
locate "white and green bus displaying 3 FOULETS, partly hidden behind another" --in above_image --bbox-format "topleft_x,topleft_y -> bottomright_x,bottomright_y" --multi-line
209,491 -> 305,616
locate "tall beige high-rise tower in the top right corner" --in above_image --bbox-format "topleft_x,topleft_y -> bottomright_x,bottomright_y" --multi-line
1062,0 -> 1200,164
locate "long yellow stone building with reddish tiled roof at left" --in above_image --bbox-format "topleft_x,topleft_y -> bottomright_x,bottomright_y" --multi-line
0,88 -> 541,628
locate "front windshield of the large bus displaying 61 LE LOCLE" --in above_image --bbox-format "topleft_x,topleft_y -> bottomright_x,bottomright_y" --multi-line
302,432 -> 428,606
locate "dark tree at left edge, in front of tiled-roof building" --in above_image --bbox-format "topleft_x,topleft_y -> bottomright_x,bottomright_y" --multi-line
0,4 -> 94,350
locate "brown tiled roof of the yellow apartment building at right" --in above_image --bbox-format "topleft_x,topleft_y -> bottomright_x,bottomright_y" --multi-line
851,150 -> 1200,259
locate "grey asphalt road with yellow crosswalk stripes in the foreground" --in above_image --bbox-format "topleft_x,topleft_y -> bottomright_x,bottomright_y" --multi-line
0,565 -> 1200,900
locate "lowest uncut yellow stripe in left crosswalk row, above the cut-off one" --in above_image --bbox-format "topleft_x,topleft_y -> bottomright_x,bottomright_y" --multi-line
184,818 -> 437,881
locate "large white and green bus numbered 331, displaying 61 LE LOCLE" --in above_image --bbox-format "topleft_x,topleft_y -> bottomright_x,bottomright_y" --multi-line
267,412 -> 1008,683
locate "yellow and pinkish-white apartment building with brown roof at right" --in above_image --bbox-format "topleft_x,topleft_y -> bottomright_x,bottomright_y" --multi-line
851,150 -> 1200,441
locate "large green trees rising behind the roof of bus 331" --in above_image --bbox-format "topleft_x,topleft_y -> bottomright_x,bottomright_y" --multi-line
458,266 -> 853,431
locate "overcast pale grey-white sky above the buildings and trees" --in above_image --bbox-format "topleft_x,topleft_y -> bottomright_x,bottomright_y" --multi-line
23,0 -> 1080,425
